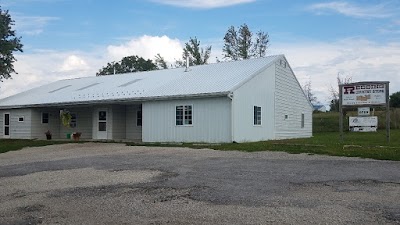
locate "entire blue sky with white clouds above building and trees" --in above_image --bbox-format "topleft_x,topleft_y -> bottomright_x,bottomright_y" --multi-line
0,0 -> 400,105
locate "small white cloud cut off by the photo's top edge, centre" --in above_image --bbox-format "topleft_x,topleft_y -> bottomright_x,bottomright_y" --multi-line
151,0 -> 256,9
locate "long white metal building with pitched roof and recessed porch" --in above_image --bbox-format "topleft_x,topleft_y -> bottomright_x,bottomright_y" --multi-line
0,55 -> 313,143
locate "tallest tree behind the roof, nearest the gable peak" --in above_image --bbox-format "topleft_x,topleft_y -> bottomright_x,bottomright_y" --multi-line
222,24 -> 269,60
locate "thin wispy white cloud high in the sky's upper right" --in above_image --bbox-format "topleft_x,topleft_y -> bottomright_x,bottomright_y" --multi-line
308,1 -> 393,18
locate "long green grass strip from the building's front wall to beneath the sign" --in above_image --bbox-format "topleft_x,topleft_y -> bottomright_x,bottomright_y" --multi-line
128,130 -> 400,161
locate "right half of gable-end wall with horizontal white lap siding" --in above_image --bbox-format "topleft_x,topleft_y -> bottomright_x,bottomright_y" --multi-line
275,58 -> 312,139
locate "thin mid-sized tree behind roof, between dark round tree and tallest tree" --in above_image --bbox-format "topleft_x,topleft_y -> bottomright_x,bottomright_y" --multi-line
179,37 -> 211,66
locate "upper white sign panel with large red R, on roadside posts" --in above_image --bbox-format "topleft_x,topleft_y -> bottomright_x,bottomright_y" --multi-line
341,84 -> 386,105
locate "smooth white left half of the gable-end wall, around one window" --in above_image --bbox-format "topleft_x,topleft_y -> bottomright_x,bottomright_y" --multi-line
233,66 -> 275,142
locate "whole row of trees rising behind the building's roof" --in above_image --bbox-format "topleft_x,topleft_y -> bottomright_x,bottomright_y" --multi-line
96,24 -> 269,76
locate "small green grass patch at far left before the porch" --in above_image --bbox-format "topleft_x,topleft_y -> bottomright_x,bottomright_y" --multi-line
0,139 -> 69,153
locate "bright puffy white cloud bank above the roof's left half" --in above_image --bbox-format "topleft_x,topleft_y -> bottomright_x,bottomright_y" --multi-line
0,35 -> 182,99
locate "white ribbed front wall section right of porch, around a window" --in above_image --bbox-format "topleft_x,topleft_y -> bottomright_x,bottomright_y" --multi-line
142,97 -> 231,143
